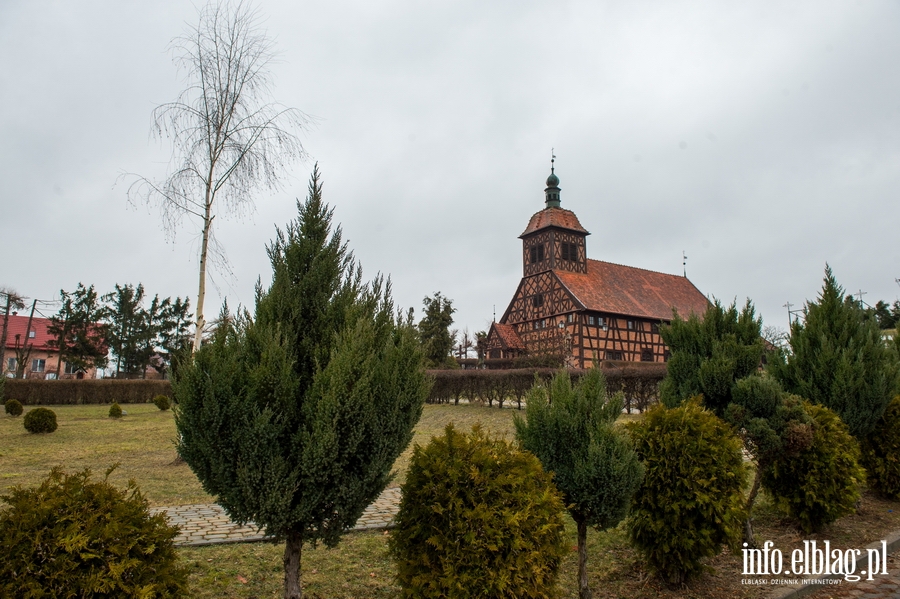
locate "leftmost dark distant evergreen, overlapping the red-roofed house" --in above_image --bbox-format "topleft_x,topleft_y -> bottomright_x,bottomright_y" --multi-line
47,283 -> 108,379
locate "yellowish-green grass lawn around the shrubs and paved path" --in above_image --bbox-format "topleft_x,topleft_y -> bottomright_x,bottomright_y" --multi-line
0,404 -> 900,599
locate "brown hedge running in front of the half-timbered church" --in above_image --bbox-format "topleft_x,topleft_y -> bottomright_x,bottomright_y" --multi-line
428,361 -> 666,413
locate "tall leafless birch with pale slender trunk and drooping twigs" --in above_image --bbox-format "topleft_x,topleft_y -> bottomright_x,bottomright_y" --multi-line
128,0 -> 309,351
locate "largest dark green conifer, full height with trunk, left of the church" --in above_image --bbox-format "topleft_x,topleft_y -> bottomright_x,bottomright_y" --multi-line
174,168 -> 428,599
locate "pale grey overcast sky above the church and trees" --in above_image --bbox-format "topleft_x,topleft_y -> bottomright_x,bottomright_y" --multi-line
0,0 -> 900,340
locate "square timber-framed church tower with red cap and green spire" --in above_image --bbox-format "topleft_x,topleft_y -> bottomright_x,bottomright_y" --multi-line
519,156 -> 590,277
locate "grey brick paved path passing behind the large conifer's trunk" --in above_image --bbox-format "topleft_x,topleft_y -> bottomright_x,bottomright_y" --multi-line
150,487 -> 400,546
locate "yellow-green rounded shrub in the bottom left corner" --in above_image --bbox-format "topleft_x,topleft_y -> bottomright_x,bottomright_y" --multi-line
0,468 -> 187,599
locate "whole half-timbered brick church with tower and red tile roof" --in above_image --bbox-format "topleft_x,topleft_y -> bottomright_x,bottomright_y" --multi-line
485,166 -> 709,368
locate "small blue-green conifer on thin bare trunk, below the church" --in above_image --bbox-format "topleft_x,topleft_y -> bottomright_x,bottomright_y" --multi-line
515,368 -> 643,599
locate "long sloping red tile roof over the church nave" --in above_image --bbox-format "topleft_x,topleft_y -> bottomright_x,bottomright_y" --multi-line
553,260 -> 709,321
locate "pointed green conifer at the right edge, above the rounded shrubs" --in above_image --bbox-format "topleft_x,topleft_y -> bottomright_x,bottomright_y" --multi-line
769,266 -> 898,439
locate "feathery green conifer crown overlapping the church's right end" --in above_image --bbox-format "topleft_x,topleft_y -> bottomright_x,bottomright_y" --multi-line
659,300 -> 765,416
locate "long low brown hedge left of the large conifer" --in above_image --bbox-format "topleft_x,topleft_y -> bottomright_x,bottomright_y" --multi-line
4,379 -> 172,406
